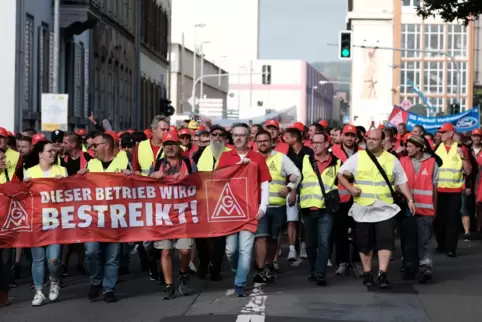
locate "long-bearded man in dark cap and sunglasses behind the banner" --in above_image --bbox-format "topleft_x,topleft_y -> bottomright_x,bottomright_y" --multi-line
193,125 -> 230,281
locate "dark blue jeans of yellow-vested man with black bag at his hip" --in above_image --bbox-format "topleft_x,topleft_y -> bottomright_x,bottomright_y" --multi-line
303,209 -> 333,275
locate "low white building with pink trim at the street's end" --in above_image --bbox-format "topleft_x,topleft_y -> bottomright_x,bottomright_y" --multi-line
228,60 -> 334,124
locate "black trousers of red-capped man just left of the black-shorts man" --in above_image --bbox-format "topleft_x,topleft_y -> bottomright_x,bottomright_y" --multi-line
331,201 -> 360,265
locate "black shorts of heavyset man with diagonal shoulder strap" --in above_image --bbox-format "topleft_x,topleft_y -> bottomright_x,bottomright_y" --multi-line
355,217 -> 397,254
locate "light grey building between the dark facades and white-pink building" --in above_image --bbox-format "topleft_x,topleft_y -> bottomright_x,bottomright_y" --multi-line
170,44 -> 229,115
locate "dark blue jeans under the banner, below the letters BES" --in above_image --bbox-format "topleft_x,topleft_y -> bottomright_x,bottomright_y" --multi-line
85,242 -> 121,293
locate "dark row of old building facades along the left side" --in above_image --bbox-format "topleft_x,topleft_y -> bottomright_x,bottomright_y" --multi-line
1,0 -> 170,130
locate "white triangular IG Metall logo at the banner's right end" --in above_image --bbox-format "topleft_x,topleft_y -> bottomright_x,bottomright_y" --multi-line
210,181 -> 248,221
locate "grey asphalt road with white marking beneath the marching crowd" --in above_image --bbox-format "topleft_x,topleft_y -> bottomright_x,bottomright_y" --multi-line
0,241 -> 482,322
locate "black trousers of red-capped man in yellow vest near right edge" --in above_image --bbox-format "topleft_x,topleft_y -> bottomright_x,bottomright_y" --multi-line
433,192 -> 462,252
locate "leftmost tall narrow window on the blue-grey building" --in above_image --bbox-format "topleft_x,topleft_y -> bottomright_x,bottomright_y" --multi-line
23,14 -> 34,112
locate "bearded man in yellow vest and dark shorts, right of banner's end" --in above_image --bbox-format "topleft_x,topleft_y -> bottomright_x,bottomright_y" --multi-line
253,130 -> 301,283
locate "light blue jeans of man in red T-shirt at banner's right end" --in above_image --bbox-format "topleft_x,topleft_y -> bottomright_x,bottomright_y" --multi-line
226,230 -> 254,287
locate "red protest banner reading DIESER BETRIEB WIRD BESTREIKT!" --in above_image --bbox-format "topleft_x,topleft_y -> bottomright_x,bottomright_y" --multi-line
0,164 -> 259,248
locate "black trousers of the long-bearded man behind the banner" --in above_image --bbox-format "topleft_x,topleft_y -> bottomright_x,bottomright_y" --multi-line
195,236 -> 226,277
